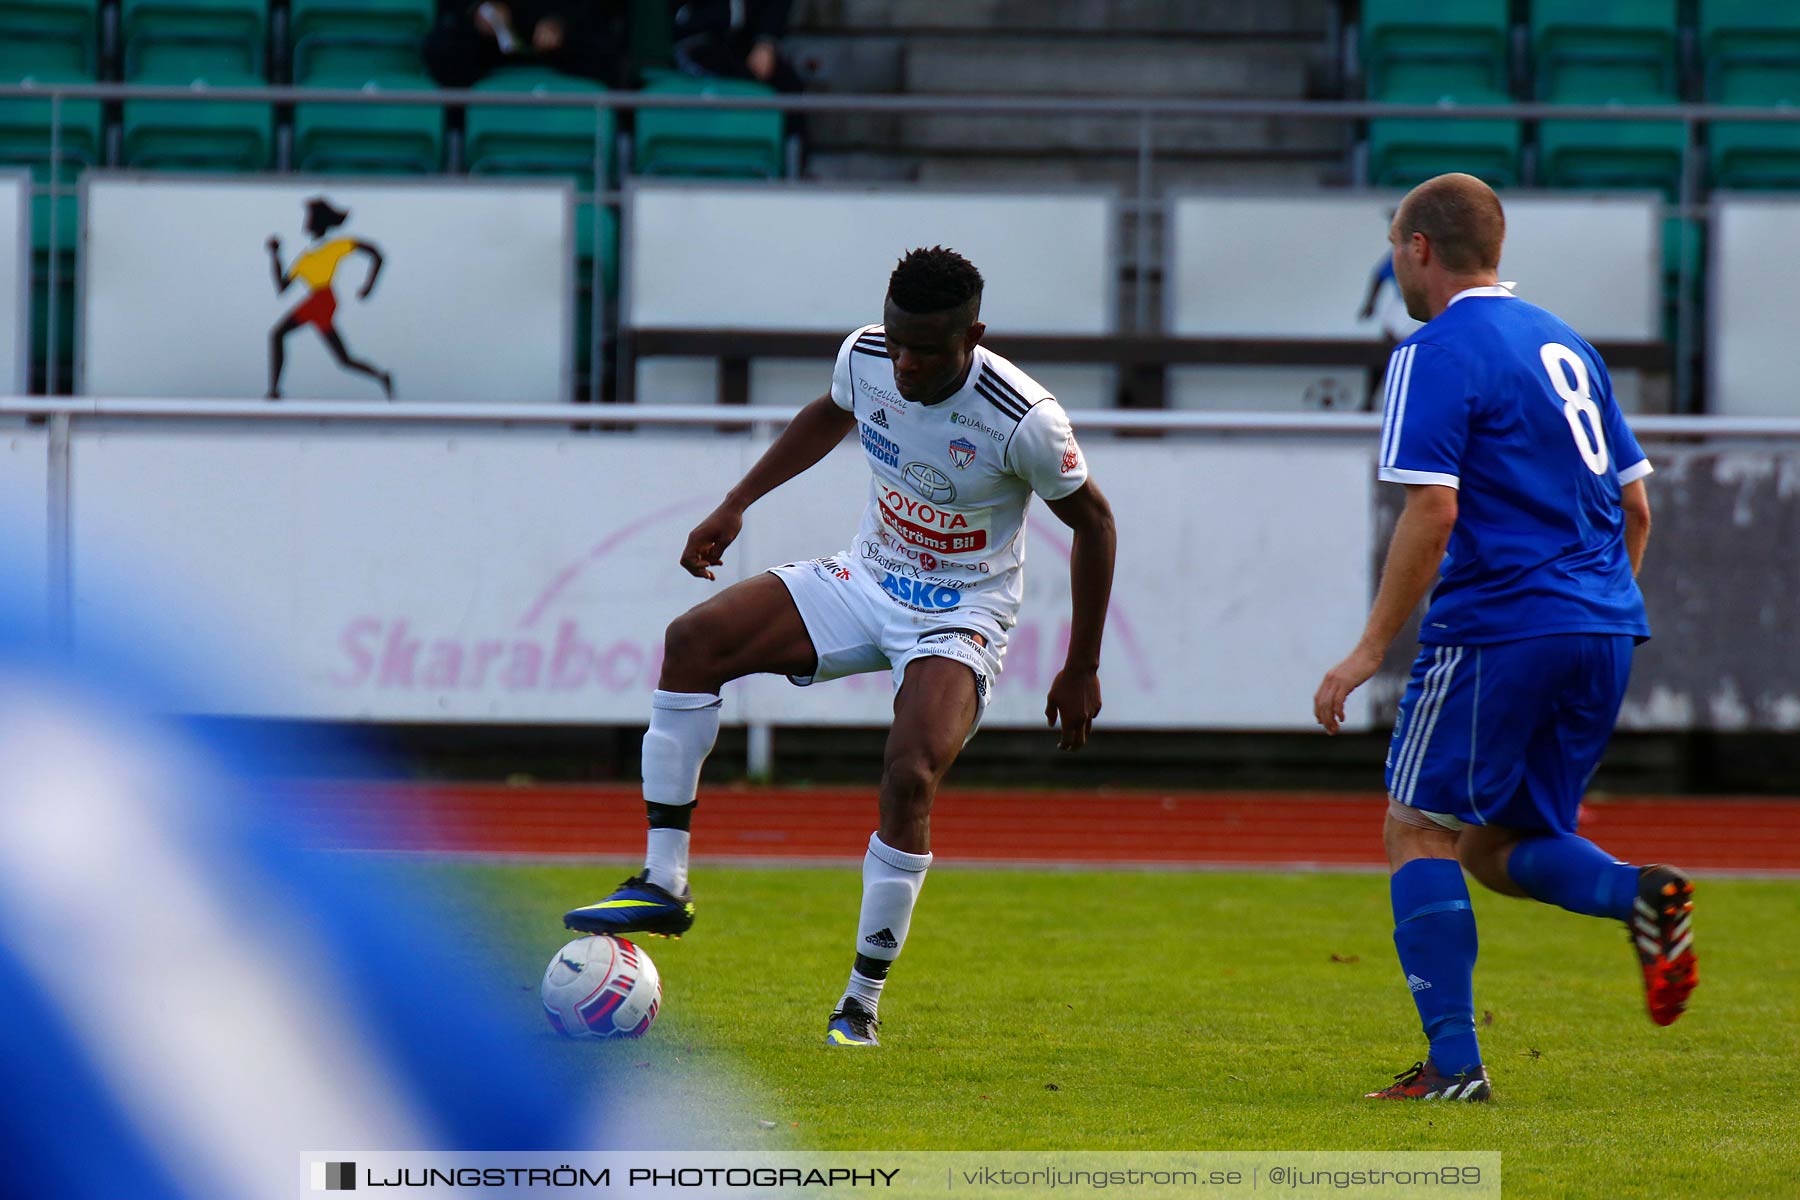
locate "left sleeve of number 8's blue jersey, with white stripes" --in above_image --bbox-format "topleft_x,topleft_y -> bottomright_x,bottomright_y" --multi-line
1377,342 -> 1474,488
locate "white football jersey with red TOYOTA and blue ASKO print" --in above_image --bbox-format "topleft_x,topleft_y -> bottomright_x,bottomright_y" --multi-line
832,326 -> 1087,630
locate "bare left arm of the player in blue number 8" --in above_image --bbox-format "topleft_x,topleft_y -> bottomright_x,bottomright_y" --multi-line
1312,484 -> 1456,734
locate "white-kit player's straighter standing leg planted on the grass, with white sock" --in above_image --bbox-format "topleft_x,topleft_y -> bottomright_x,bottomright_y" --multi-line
824,657 -> 979,1045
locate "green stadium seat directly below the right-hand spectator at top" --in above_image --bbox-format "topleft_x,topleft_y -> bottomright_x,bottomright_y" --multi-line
634,72 -> 785,178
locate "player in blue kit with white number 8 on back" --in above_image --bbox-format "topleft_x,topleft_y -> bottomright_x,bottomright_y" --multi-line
1312,175 -> 1697,1101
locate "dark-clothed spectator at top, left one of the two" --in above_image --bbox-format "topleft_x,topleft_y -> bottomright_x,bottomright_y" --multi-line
425,0 -> 628,88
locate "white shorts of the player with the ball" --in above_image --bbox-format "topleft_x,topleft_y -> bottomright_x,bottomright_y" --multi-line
769,551 -> 1006,738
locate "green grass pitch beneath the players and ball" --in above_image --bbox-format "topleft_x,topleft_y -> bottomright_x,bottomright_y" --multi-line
405,864 -> 1800,1196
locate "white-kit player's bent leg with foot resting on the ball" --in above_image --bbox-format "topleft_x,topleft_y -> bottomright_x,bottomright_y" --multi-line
563,574 -> 817,936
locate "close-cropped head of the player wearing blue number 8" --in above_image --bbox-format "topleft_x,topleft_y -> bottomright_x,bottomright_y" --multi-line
1388,175 -> 1507,320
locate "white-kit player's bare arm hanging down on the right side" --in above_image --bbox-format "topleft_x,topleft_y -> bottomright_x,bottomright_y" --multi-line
1044,479 -> 1118,750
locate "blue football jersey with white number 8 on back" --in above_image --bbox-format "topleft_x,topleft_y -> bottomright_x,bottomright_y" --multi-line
1379,286 -> 1651,646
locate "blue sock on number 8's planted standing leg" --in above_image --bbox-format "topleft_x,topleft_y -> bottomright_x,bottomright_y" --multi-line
1390,858 -> 1481,1076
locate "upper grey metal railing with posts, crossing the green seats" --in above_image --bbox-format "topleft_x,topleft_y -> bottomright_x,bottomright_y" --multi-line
0,83 -> 1800,412
